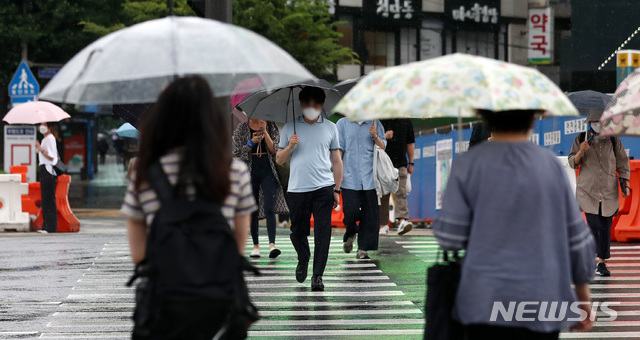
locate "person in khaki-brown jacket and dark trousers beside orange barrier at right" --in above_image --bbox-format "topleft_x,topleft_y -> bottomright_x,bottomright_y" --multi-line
569,110 -> 631,276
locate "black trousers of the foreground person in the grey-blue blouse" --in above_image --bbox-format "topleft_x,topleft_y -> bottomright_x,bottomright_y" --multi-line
465,325 -> 560,340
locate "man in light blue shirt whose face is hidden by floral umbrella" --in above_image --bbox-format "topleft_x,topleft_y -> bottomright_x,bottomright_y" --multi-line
337,118 -> 387,259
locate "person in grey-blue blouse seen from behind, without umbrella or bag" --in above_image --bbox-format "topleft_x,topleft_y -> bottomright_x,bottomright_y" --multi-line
434,111 -> 595,339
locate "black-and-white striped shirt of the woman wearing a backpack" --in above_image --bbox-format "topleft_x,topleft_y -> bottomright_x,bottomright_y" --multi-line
120,152 -> 257,228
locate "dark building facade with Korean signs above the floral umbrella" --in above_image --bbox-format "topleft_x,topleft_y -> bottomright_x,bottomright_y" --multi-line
330,0 -> 571,83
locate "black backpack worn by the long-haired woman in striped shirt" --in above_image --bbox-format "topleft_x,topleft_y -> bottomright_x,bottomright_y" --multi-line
129,163 -> 259,339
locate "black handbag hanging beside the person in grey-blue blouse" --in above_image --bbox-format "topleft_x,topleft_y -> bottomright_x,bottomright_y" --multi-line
424,252 -> 464,340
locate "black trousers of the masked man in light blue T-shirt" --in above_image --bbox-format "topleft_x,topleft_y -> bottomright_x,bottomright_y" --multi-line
287,187 -> 334,276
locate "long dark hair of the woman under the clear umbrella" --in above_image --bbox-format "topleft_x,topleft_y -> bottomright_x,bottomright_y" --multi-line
135,76 -> 231,204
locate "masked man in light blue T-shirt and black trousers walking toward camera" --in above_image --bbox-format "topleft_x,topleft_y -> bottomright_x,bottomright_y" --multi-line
276,86 -> 342,291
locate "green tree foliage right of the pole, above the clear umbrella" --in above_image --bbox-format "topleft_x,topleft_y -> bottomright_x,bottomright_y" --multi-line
233,0 -> 356,76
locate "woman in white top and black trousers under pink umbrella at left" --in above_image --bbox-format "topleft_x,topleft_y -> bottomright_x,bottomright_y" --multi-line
36,123 -> 60,233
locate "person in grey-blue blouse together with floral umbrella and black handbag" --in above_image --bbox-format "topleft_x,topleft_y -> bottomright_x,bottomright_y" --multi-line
335,54 -> 595,340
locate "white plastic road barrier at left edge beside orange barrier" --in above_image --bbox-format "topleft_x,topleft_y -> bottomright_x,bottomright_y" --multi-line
0,175 -> 29,231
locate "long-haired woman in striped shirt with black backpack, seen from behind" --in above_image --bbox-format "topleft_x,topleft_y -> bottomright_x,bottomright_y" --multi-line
122,76 -> 256,339
